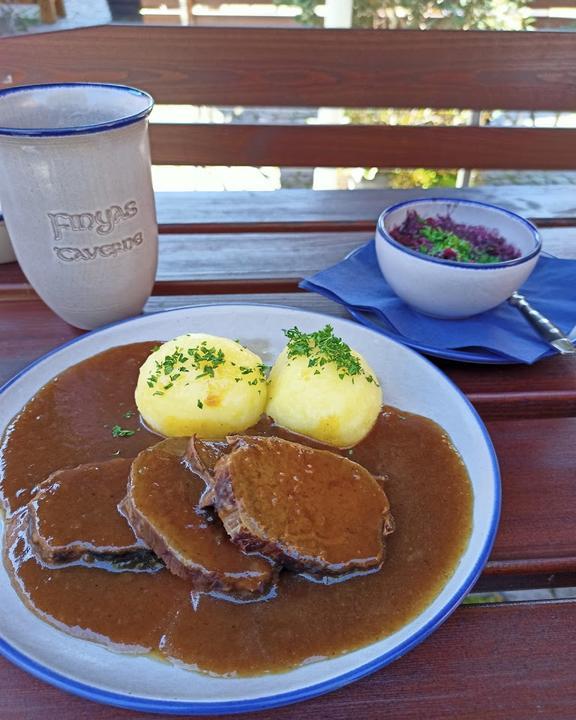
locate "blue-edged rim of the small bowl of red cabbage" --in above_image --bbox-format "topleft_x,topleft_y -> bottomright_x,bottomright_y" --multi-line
376,197 -> 542,270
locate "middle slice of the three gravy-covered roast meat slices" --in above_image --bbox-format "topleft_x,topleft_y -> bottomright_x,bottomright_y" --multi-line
121,438 -> 278,599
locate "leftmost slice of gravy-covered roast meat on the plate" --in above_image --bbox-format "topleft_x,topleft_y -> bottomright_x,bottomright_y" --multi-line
27,458 -> 162,570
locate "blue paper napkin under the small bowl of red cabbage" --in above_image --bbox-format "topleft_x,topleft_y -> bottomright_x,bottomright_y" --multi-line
300,241 -> 576,365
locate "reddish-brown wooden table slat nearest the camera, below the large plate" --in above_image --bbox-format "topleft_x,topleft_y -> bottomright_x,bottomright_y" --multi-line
0,600 -> 576,720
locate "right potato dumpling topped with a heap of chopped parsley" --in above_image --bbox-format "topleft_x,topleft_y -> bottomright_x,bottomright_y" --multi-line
266,325 -> 382,447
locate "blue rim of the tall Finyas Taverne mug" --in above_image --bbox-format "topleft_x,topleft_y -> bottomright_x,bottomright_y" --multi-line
0,82 -> 154,137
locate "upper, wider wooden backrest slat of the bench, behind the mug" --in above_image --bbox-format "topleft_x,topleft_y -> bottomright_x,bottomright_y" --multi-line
0,26 -> 576,110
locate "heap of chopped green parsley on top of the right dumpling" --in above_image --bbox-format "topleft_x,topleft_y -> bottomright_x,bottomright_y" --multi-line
284,325 -> 377,384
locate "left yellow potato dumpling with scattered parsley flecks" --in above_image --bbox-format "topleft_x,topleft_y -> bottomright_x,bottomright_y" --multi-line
135,333 -> 267,439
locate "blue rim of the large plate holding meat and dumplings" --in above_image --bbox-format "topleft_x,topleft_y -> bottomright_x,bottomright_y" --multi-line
0,303 -> 501,715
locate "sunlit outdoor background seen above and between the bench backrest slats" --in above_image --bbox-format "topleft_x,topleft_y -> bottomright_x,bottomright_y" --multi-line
0,0 -> 576,191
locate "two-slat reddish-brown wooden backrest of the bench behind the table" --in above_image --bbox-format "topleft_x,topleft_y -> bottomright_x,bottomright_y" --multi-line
0,25 -> 576,169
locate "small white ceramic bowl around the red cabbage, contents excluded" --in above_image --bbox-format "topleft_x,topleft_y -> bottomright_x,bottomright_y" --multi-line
376,198 -> 542,319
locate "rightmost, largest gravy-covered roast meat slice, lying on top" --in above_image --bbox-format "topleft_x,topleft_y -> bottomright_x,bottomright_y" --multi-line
214,436 -> 393,576
